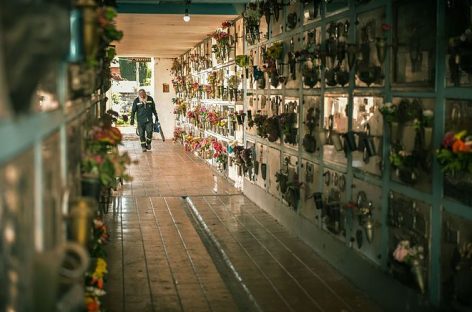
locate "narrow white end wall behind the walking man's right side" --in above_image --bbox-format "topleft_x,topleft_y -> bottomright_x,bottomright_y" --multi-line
152,58 -> 175,141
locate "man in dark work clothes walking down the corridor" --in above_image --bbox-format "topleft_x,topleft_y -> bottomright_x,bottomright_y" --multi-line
130,89 -> 159,152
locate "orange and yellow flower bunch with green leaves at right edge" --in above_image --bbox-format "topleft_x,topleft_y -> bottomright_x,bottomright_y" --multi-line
436,130 -> 472,174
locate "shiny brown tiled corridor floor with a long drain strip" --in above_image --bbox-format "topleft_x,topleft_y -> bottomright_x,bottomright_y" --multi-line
104,133 -> 380,312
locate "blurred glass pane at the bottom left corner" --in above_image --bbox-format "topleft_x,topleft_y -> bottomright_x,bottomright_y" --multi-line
0,150 -> 35,311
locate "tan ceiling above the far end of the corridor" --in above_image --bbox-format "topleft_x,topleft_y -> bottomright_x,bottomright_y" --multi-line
116,13 -> 237,58
